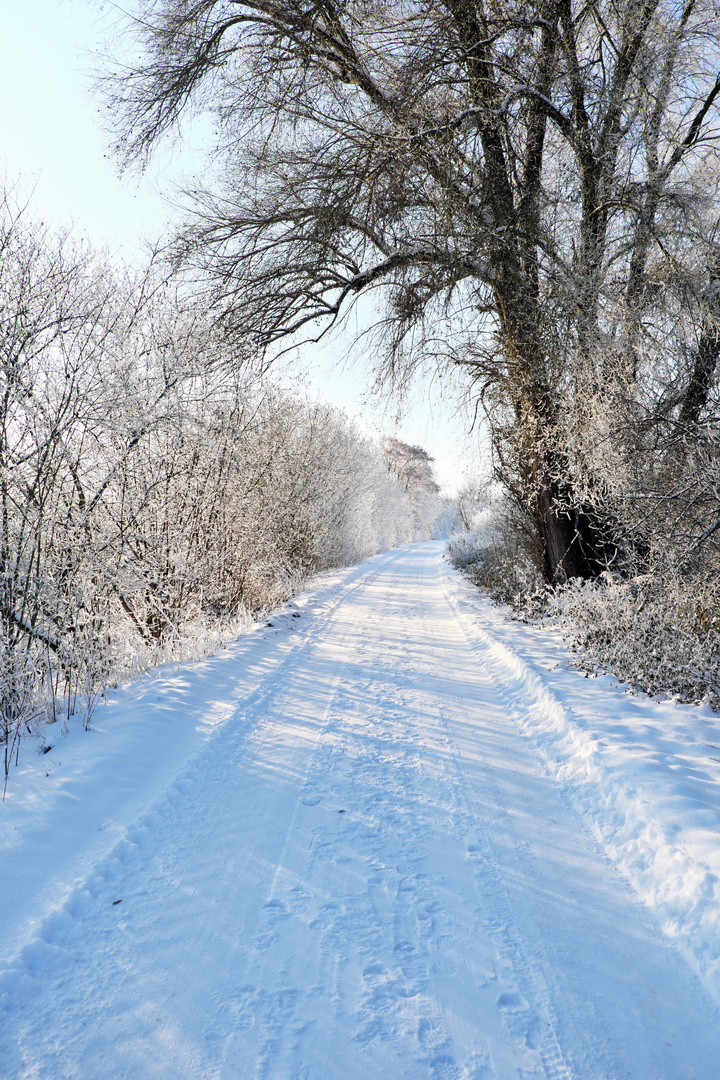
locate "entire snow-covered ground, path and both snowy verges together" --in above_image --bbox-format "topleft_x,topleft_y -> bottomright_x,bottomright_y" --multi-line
0,543 -> 720,1080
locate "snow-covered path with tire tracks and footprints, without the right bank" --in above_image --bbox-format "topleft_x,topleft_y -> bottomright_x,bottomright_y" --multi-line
0,544 -> 720,1080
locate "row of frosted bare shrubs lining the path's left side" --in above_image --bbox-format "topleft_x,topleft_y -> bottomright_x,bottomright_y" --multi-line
0,194 -> 445,778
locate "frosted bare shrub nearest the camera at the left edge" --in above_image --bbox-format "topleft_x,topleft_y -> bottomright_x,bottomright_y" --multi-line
0,195 -> 119,772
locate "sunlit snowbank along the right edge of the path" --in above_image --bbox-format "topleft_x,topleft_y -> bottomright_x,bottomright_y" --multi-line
443,564 -> 720,1003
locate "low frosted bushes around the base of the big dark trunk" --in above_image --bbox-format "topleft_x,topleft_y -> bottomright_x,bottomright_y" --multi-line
449,496 -> 720,708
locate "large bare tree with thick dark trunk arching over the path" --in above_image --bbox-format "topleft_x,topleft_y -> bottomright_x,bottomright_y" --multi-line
99,0 -> 720,580
